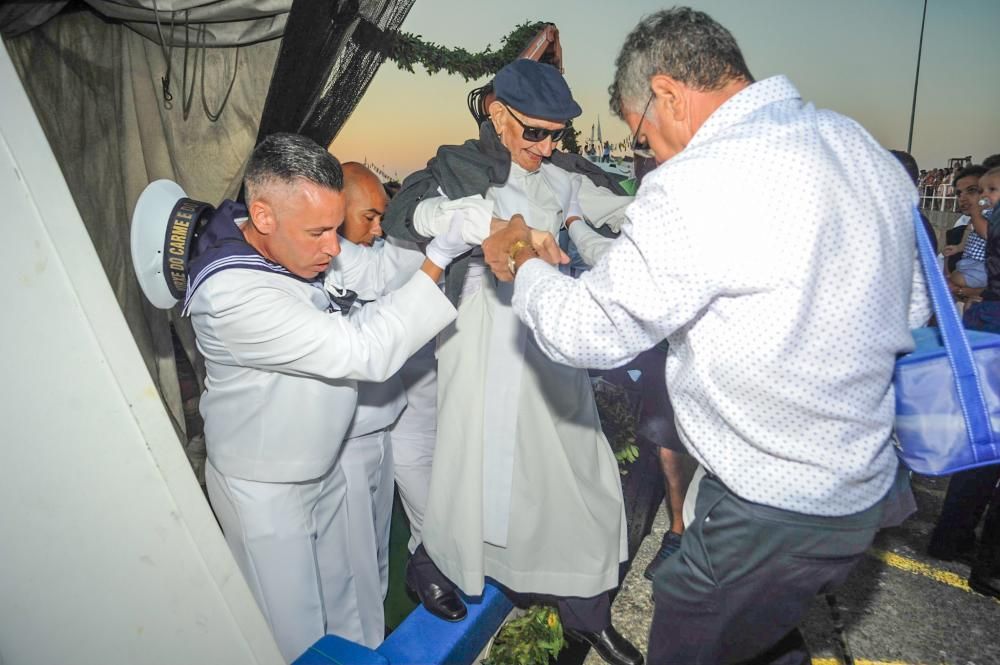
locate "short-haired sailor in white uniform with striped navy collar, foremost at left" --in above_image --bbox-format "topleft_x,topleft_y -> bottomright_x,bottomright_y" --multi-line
185,134 -> 468,662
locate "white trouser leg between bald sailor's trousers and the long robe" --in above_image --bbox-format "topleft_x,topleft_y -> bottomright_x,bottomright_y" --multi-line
391,341 -> 437,553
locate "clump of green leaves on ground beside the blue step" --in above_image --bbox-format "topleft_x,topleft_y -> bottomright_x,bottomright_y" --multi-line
482,605 -> 566,665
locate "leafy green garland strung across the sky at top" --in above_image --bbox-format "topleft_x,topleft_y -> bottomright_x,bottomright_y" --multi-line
378,21 -> 545,81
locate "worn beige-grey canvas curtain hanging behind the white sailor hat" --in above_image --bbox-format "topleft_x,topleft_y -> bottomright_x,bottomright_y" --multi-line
5,12 -> 278,440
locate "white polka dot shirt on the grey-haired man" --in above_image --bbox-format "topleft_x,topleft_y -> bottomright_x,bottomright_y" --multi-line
514,76 -> 929,515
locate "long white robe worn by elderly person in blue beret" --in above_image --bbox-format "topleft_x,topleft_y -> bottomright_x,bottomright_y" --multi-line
415,164 -> 631,597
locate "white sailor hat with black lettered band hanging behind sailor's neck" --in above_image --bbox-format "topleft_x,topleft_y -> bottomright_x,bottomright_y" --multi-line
131,180 -> 214,309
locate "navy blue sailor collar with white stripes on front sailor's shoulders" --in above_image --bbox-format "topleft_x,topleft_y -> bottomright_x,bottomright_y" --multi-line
184,199 -> 322,314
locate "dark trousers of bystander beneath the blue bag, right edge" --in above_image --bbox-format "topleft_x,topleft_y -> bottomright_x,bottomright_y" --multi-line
929,466 -> 1000,558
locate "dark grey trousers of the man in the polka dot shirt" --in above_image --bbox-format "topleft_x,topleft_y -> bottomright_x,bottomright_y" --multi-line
646,476 -> 892,665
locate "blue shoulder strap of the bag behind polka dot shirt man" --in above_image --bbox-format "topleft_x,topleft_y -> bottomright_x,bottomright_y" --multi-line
913,207 -> 993,446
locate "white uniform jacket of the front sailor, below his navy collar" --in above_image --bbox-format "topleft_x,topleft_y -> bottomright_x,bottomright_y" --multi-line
187,268 -> 455,482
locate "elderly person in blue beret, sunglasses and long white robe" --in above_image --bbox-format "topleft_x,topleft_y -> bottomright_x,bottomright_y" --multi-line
383,60 -> 642,665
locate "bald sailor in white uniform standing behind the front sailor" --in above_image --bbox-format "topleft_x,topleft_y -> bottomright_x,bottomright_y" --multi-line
316,162 -> 437,646
